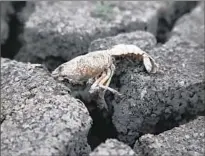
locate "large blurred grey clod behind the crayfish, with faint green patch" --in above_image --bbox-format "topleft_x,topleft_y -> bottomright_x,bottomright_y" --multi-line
15,1 -> 195,70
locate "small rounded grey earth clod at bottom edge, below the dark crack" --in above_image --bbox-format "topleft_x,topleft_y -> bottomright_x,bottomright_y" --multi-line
90,139 -> 137,156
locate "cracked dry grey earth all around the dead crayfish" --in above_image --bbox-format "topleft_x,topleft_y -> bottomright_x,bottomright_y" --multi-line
1,1 -> 205,156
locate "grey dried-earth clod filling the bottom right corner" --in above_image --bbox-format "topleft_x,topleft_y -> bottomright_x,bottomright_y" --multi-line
134,116 -> 205,156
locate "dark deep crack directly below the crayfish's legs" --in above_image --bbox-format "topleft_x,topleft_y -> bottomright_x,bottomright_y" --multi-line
72,87 -> 117,150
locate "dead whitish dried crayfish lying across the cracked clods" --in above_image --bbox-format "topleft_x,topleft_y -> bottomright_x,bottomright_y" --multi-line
52,44 -> 158,93
